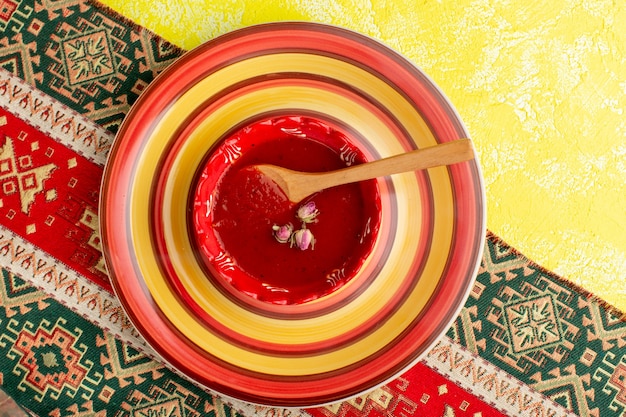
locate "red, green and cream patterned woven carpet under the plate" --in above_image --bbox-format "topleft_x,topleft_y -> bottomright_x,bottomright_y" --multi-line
0,0 -> 626,417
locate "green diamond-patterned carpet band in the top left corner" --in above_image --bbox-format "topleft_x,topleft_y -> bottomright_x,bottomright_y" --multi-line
0,0 -> 184,132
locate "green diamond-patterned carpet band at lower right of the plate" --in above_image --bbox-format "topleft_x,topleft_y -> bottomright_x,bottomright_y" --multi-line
447,233 -> 626,417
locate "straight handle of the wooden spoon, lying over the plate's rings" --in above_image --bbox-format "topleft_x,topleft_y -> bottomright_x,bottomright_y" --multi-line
311,139 -> 475,190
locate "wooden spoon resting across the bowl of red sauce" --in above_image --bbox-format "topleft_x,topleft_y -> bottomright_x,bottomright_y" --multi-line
254,139 -> 474,203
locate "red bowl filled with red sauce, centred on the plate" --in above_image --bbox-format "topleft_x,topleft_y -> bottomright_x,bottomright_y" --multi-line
192,116 -> 380,304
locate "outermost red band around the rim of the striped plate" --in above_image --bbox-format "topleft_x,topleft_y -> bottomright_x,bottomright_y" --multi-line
100,22 -> 486,407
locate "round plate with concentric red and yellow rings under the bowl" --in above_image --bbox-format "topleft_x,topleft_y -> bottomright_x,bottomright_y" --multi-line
100,23 -> 485,407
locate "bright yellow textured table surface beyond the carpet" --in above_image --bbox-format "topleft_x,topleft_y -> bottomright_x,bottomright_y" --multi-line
102,0 -> 626,311
